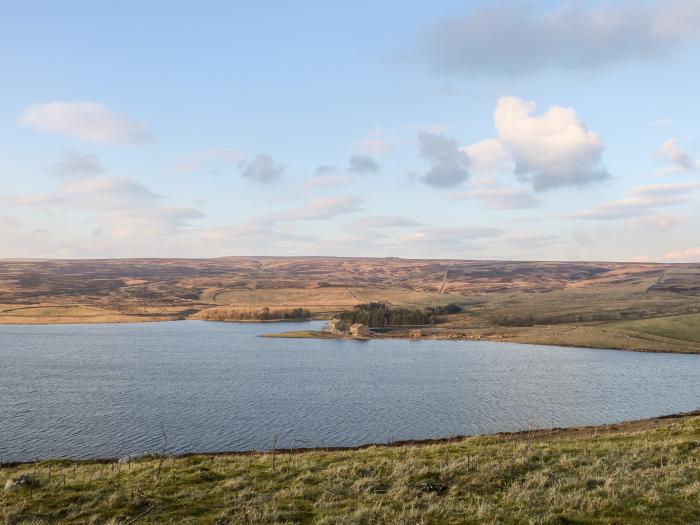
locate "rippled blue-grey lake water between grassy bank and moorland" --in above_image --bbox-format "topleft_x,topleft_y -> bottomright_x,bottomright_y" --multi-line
0,321 -> 700,461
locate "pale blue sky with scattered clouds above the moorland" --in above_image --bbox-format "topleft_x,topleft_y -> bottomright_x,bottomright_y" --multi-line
0,0 -> 700,262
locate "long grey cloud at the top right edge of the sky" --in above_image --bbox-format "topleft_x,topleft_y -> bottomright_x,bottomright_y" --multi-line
428,0 -> 700,75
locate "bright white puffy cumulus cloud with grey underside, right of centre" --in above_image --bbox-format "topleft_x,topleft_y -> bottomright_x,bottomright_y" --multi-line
493,97 -> 609,191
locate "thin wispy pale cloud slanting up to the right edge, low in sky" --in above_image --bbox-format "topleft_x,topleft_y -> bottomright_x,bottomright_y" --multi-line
566,182 -> 700,220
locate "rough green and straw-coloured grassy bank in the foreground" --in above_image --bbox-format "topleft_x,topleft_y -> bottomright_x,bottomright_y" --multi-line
0,416 -> 700,524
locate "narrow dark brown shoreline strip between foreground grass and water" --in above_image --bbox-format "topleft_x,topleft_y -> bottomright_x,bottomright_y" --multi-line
0,408 -> 700,470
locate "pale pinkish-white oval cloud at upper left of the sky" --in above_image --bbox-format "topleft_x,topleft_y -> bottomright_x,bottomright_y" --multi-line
19,101 -> 149,144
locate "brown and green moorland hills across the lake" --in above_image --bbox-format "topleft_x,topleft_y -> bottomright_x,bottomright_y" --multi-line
0,257 -> 700,352
